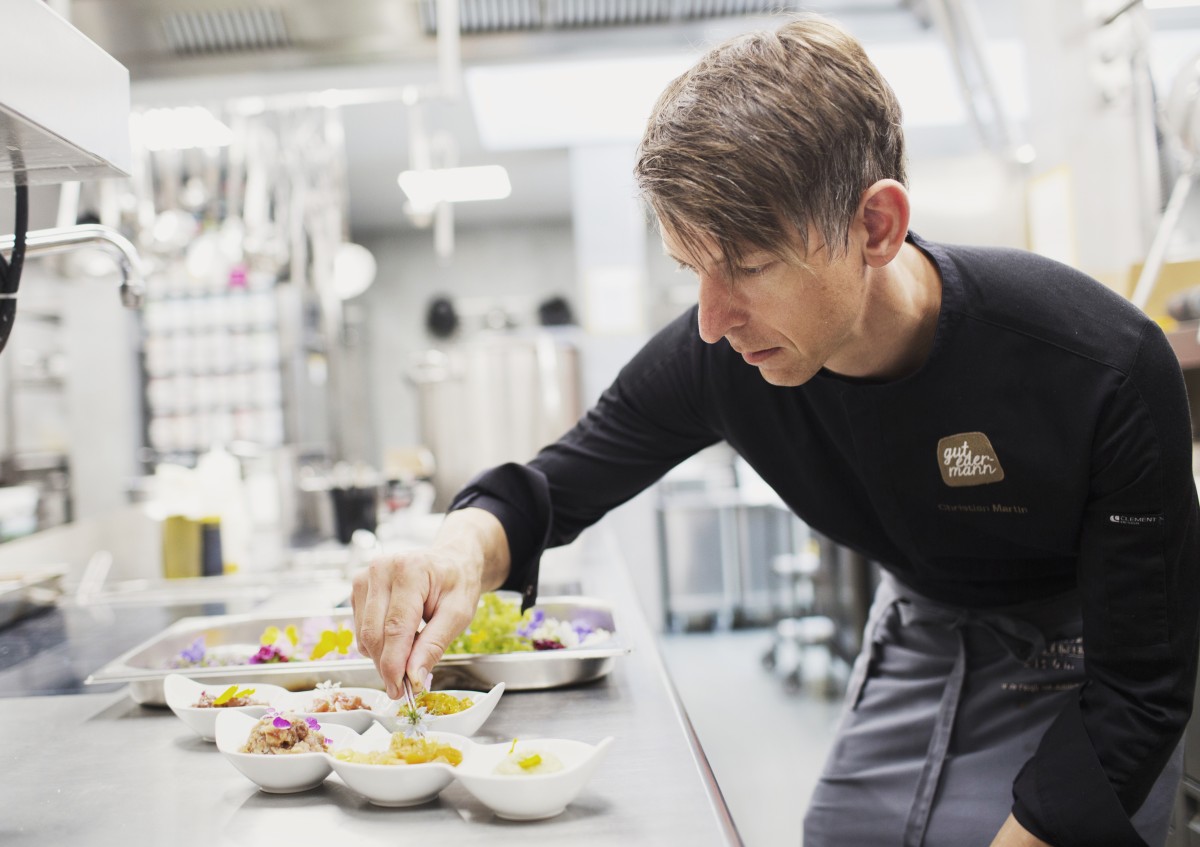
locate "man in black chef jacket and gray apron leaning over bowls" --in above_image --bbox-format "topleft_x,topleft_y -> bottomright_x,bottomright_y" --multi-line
354,17 -> 1200,847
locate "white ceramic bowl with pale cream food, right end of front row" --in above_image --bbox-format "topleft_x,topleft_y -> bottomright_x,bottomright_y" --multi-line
455,737 -> 613,821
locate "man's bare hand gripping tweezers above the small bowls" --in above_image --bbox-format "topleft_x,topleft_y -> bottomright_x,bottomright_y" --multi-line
350,509 -> 509,699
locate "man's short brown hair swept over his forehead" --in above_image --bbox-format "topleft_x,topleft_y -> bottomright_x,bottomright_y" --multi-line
635,16 -> 906,271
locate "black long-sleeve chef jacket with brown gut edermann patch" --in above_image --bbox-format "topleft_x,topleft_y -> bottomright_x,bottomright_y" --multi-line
452,235 -> 1200,847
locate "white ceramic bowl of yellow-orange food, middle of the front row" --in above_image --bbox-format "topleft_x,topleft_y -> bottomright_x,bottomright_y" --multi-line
330,723 -> 465,806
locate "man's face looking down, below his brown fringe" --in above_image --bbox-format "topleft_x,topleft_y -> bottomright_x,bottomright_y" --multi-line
662,229 -> 866,386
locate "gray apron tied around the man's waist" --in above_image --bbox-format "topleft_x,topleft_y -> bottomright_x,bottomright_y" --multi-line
804,572 -> 1183,847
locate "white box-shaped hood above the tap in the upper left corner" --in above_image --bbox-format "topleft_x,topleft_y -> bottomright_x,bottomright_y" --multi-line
0,0 -> 132,186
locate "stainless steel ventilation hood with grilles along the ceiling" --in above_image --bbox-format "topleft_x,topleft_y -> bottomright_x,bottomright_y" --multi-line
63,0 -> 917,83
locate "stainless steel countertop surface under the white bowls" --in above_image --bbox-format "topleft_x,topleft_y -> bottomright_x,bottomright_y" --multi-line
0,530 -> 738,847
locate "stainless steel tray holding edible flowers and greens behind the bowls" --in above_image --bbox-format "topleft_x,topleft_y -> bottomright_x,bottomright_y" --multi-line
84,596 -> 629,705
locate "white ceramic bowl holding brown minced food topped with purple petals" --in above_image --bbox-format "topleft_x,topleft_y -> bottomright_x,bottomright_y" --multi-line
216,710 -> 359,794
